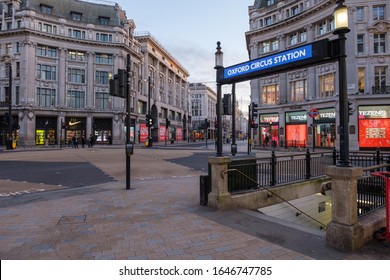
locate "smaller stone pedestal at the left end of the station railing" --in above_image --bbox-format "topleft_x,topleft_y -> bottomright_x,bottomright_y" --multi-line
208,157 -> 233,210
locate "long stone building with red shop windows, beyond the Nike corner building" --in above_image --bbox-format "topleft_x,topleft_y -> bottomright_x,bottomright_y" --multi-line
135,32 -> 191,142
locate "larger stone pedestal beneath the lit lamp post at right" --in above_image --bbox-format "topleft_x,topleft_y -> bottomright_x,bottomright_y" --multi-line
326,166 -> 364,251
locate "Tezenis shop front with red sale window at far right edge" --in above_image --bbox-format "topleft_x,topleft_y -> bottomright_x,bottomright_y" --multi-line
359,106 -> 390,149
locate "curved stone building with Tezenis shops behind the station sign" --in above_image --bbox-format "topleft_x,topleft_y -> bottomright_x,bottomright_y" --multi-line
246,0 -> 390,150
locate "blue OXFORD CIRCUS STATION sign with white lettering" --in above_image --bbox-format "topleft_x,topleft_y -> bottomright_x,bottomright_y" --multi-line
224,44 -> 313,79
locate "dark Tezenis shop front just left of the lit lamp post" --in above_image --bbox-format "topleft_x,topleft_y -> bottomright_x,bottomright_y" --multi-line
313,108 -> 336,148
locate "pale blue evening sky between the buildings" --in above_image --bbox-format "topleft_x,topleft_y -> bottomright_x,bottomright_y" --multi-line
114,0 -> 254,111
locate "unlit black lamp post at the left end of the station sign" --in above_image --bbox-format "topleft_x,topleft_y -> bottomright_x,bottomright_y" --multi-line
214,41 -> 223,157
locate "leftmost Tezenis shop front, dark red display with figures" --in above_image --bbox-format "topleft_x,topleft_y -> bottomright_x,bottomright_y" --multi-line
259,113 -> 280,147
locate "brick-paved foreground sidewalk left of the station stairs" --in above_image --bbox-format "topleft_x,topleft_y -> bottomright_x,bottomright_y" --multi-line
0,177 -> 308,260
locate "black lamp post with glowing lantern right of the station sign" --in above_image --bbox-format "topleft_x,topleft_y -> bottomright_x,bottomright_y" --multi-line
333,0 -> 351,167
